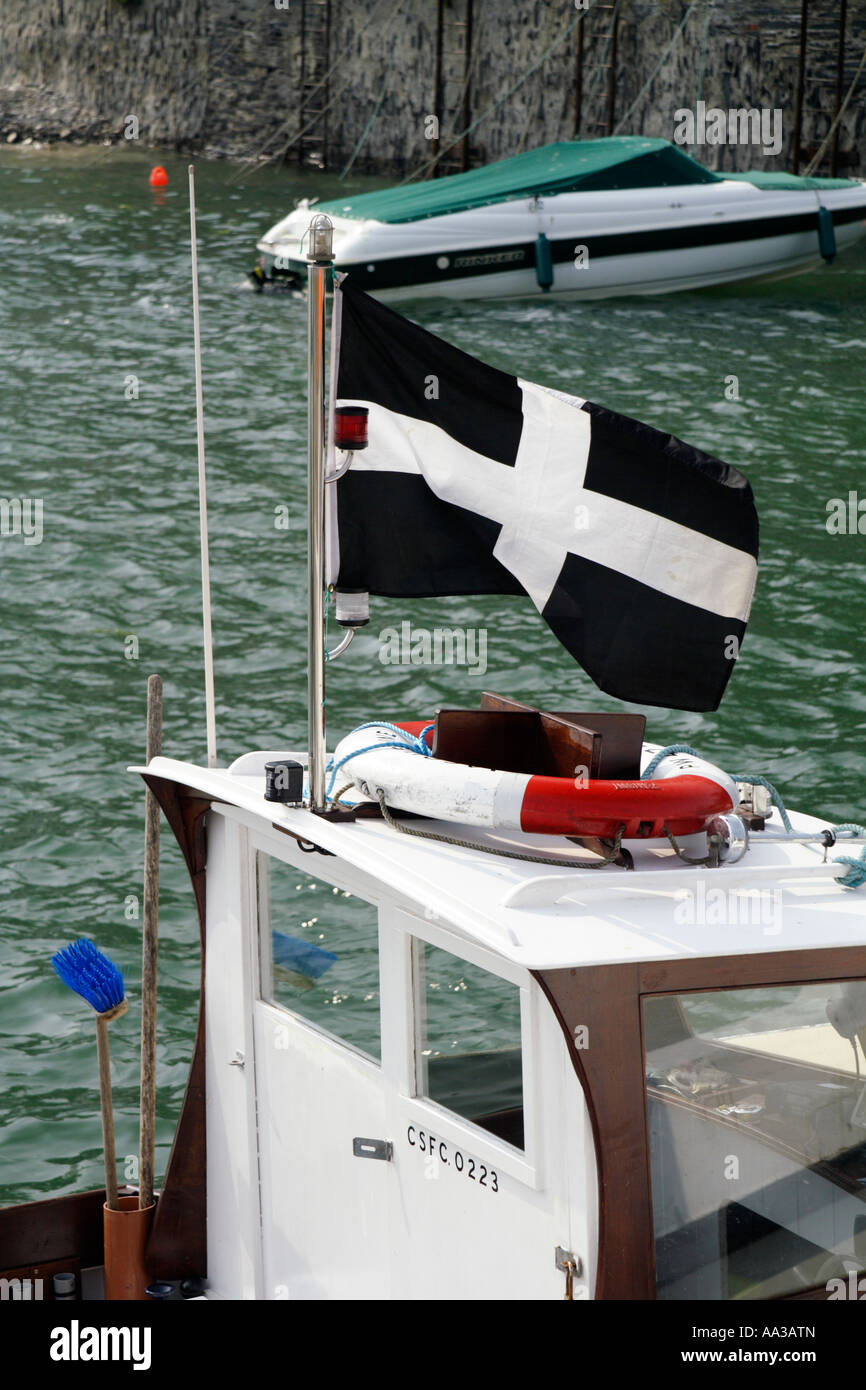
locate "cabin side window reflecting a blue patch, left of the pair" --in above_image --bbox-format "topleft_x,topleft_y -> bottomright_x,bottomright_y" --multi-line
256,852 -> 381,1061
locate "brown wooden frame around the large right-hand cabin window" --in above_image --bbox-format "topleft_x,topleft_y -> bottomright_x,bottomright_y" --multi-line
532,947 -> 866,1300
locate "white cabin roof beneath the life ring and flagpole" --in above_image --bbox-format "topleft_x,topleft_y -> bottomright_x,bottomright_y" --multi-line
129,749 -> 866,969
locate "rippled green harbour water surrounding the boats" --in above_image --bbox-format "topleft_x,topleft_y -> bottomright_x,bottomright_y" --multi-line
0,149 -> 866,1202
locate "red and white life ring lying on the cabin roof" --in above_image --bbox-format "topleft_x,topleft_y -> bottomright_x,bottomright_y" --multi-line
332,721 -> 738,840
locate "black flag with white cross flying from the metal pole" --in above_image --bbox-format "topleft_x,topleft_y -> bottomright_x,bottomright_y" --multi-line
327,279 -> 758,710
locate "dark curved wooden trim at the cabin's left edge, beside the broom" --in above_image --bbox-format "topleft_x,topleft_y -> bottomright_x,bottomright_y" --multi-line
142,773 -> 211,1279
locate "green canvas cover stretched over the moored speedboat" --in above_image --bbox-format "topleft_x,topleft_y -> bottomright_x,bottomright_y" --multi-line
316,135 -> 858,222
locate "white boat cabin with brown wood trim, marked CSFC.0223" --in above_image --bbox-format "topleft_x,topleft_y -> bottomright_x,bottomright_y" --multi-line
127,717 -> 866,1300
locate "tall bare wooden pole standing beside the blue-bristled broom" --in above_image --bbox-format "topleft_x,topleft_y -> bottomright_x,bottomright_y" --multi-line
139,676 -> 163,1211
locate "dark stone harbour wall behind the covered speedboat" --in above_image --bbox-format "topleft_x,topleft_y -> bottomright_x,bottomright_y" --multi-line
0,0 -> 866,177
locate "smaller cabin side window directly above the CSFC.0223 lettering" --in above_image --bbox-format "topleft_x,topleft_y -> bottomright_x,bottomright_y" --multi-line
414,940 -> 524,1148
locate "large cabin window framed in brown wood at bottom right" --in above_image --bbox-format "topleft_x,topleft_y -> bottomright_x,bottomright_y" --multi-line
642,981 -> 866,1300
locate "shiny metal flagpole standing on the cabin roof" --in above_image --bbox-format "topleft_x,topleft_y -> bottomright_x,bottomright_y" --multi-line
307,213 -> 334,810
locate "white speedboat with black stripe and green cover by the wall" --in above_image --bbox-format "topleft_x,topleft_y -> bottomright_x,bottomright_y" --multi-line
253,136 -> 866,300
